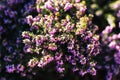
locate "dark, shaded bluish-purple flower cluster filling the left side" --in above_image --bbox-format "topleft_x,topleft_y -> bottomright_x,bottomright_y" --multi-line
0,0 -> 35,80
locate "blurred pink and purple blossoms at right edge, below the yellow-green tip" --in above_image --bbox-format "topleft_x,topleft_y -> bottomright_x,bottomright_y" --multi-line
102,26 -> 120,80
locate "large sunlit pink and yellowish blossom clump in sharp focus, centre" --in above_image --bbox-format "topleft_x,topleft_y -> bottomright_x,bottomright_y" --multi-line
22,0 -> 100,76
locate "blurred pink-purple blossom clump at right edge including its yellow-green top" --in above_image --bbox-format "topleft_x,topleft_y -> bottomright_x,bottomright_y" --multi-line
100,8 -> 120,80
